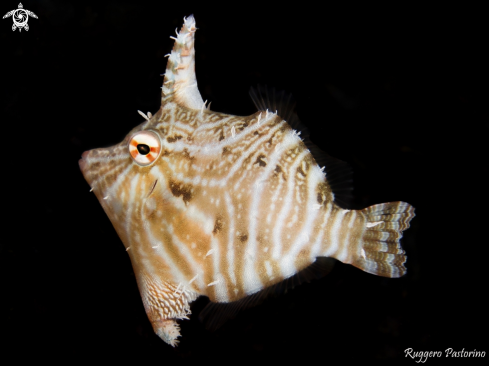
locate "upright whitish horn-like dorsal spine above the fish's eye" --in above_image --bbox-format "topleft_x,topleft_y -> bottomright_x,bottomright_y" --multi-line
161,15 -> 204,109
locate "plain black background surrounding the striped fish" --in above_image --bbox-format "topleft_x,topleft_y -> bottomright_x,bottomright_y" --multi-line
0,0 -> 489,364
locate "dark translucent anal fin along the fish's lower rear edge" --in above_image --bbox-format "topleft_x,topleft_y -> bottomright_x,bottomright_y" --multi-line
199,257 -> 335,331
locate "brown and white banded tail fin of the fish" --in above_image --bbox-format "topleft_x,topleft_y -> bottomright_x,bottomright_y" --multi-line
352,202 -> 415,277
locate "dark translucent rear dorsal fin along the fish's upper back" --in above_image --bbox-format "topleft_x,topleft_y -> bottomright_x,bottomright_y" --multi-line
250,85 -> 353,209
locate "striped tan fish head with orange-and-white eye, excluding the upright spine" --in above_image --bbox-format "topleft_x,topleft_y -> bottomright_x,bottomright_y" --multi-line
79,109 -> 190,249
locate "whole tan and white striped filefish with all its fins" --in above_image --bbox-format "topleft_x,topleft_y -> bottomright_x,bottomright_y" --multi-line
79,16 -> 415,346
